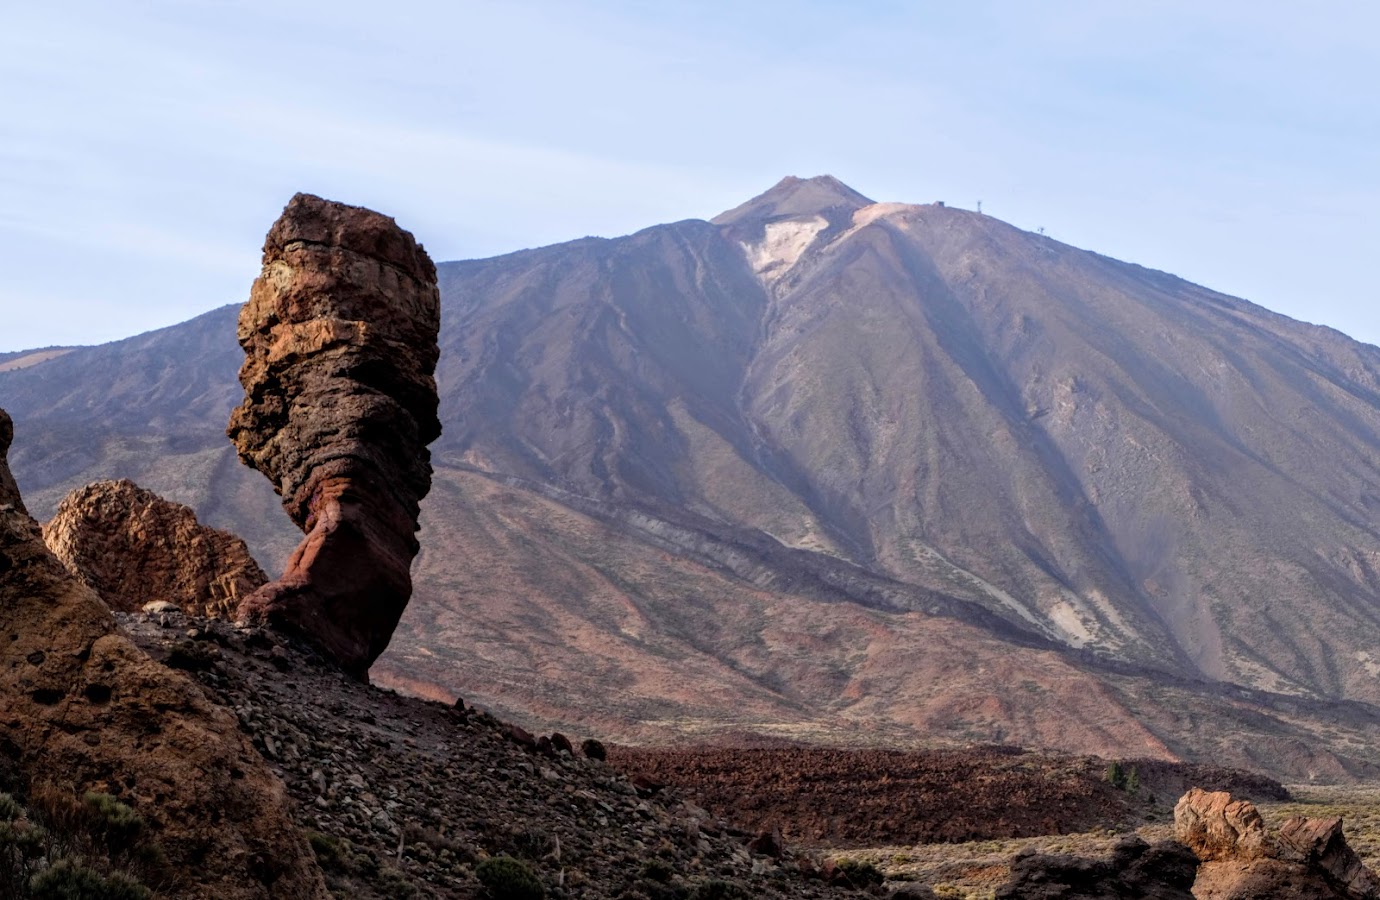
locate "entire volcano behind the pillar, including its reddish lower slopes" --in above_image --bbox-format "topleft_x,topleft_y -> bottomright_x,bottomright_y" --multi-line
8,177 -> 1380,776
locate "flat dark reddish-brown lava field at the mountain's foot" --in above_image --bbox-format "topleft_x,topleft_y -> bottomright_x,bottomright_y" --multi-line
609,747 -> 1286,848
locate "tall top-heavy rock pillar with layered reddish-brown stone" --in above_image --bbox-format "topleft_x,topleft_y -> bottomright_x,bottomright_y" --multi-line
228,193 -> 440,676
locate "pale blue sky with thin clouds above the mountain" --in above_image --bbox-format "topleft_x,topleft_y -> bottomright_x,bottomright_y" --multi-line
0,0 -> 1380,351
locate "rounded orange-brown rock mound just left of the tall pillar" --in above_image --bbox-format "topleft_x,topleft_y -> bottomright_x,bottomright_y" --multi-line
43,480 -> 268,618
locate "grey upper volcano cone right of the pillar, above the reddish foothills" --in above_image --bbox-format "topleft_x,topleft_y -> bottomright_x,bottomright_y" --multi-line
427,173 -> 1380,700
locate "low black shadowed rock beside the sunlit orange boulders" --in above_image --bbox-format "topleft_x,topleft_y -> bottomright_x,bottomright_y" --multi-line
995,835 -> 1198,900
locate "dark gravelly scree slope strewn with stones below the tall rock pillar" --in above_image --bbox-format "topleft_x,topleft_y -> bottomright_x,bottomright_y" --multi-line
120,610 -> 858,900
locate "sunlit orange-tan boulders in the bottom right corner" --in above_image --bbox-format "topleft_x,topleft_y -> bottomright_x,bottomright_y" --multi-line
1174,788 -> 1380,900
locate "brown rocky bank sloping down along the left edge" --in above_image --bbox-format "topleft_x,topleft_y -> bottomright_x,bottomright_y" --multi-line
0,410 -> 327,899
